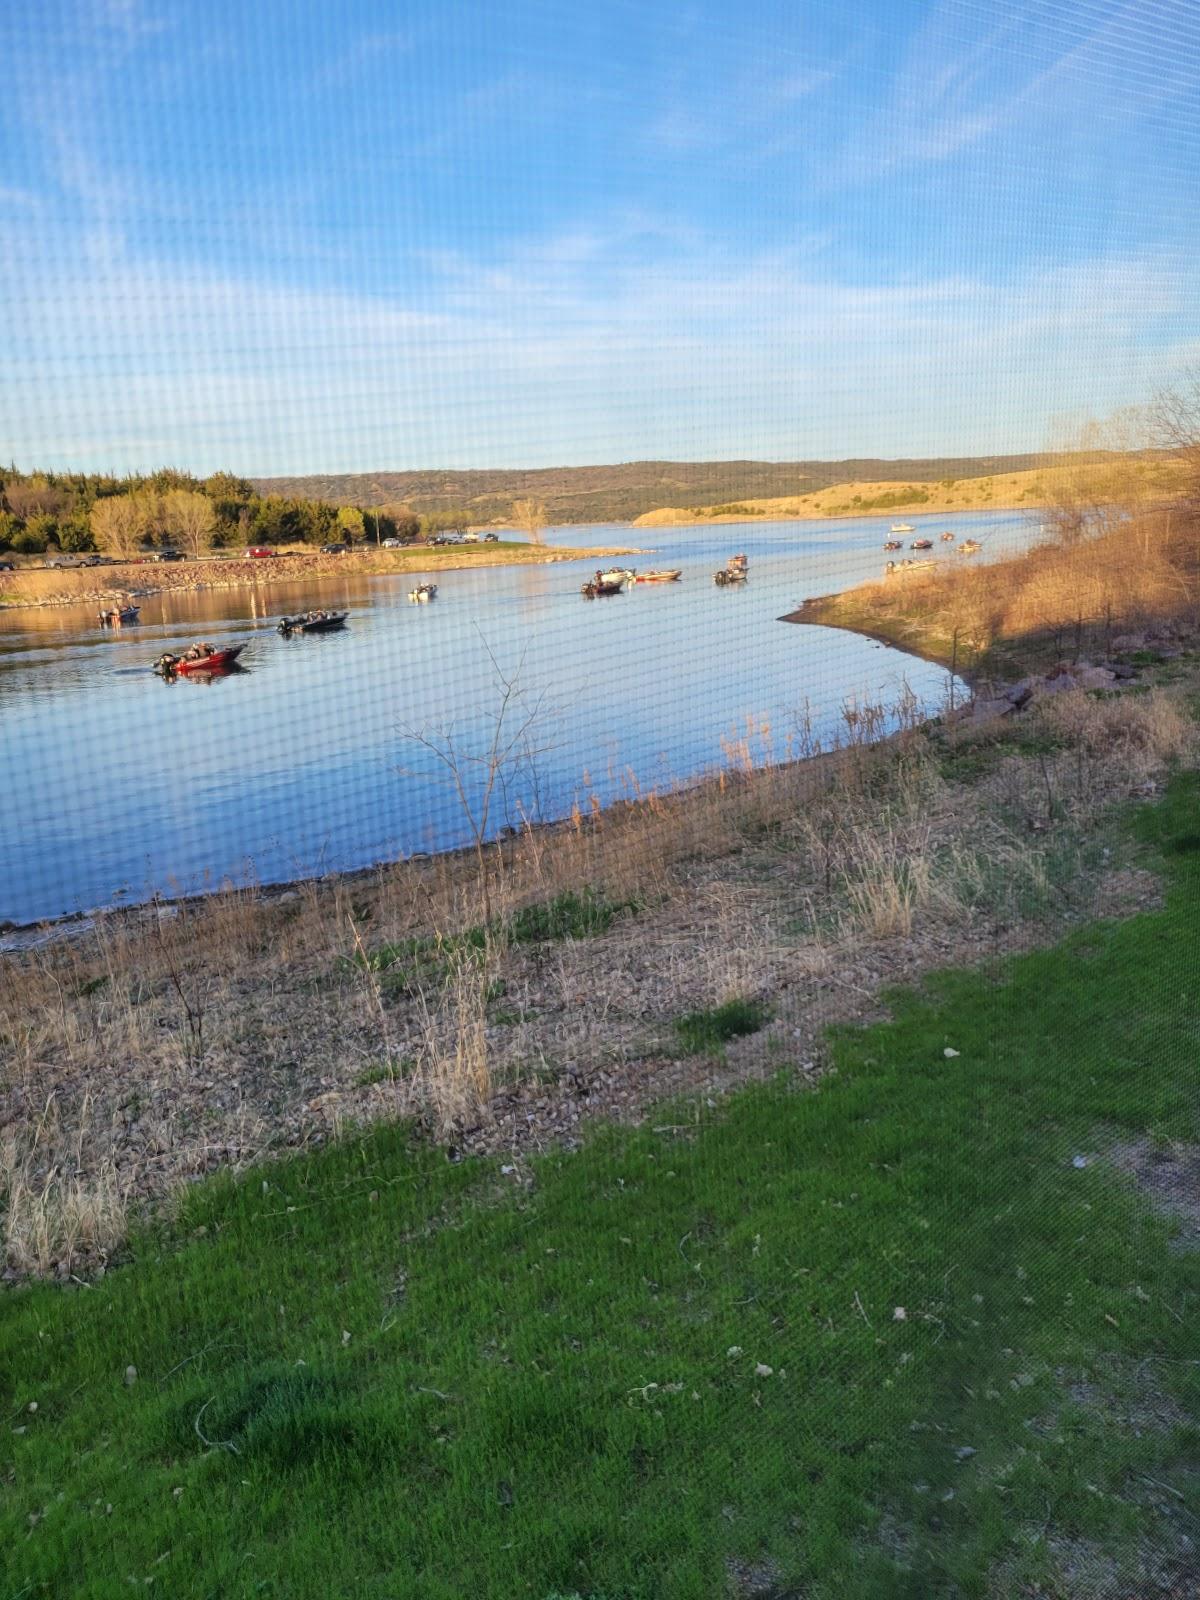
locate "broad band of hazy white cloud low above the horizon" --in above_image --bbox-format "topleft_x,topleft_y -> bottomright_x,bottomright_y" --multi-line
0,218 -> 1197,472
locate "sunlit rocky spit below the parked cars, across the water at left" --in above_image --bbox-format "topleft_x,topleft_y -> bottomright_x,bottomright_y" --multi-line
0,542 -> 645,611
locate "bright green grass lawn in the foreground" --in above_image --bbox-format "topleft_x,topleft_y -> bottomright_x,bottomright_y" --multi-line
0,779 -> 1200,1600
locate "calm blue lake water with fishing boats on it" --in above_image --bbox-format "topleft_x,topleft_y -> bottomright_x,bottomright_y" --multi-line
0,514 -> 1035,923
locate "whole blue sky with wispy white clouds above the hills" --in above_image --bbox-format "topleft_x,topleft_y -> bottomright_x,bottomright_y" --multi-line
0,0 -> 1200,474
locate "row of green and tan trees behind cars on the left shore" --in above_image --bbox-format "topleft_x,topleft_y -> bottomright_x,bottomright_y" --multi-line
0,467 -> 441,560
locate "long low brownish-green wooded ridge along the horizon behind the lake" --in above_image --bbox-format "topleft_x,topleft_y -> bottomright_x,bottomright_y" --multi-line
253,454 -> 1081,525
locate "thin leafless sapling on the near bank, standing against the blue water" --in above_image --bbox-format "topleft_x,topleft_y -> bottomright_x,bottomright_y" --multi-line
402,634 -> 552,925
